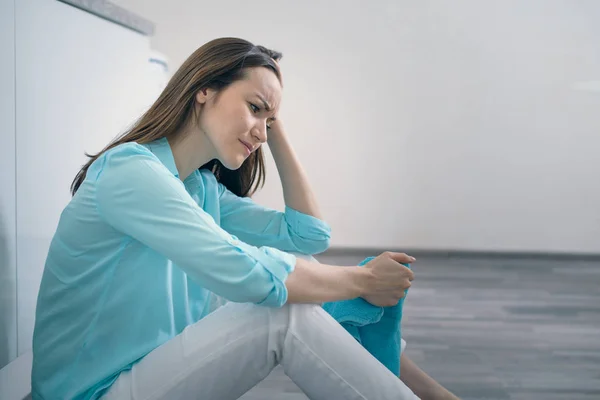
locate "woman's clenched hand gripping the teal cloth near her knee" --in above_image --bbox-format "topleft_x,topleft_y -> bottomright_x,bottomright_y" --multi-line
361,251 -> 415,307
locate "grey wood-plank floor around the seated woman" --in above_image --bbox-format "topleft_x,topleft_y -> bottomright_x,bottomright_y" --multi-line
242,254 -> 600,400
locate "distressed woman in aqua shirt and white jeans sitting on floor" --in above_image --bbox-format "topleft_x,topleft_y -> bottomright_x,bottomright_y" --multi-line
32,38 -> 458,400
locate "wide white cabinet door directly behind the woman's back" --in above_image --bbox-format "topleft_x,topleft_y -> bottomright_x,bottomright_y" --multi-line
16,0 -> 151,354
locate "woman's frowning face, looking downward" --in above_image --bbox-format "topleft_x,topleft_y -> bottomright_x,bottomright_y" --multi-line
196,67 -> 282,170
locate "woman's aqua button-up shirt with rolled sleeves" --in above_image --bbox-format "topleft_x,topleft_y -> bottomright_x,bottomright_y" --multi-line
32,139 -> 331,399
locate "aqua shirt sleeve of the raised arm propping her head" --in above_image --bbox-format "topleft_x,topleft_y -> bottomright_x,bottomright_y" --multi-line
219,184 -> 331,254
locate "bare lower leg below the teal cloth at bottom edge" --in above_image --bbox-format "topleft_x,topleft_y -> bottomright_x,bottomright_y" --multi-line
400,354 -> 460,400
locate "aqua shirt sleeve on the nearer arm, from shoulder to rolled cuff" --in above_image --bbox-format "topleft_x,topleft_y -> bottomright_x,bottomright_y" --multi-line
88,144 -> 296,307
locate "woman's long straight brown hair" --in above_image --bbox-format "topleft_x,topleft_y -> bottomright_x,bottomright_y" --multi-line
71,38 -> 281,197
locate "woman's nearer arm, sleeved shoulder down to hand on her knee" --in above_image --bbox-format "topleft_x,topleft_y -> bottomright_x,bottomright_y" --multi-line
94,144 -> 412,307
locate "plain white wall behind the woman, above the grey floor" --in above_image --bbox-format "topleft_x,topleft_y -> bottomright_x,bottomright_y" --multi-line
115,0 -> 600,253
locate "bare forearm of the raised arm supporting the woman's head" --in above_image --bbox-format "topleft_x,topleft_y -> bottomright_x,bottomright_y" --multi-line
267,119 -> 322,219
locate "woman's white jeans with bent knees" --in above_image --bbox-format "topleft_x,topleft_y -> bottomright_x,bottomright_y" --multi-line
103,303 -> 418,400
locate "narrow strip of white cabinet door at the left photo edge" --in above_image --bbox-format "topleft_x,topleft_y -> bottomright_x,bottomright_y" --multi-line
0,0 -> 17,370
